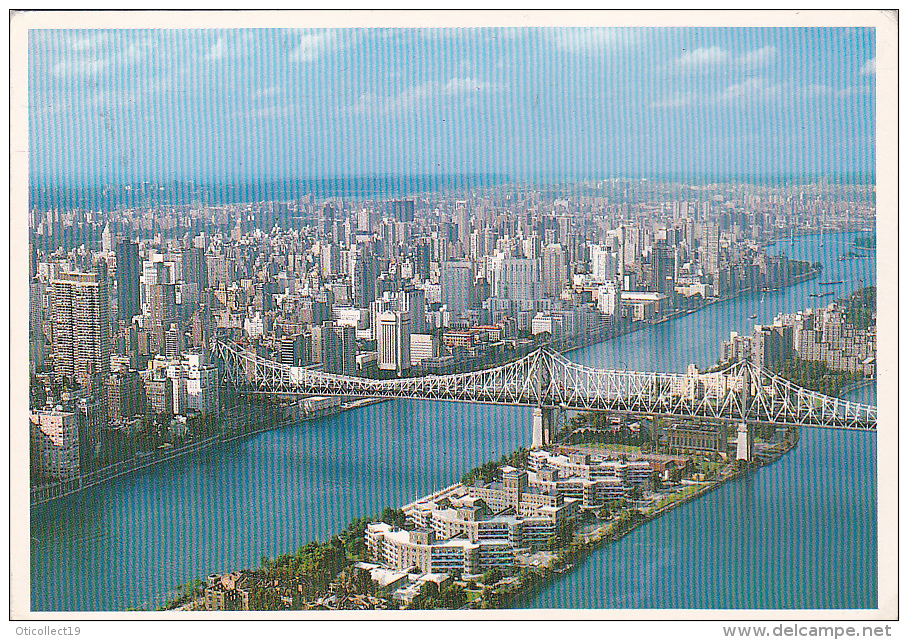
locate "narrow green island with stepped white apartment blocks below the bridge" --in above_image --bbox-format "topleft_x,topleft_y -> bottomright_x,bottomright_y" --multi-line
162,412 -> 798,611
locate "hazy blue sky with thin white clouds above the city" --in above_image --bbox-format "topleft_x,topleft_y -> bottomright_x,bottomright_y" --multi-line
28,28 -> 875,184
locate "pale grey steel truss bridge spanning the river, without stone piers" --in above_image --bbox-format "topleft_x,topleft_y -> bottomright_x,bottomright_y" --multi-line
213,340 -> 877,440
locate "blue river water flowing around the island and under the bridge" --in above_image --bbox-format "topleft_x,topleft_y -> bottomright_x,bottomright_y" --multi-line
31,234 -> 877,611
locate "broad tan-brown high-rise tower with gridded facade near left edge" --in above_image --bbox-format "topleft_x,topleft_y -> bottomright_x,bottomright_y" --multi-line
51,272 -> 110,393
